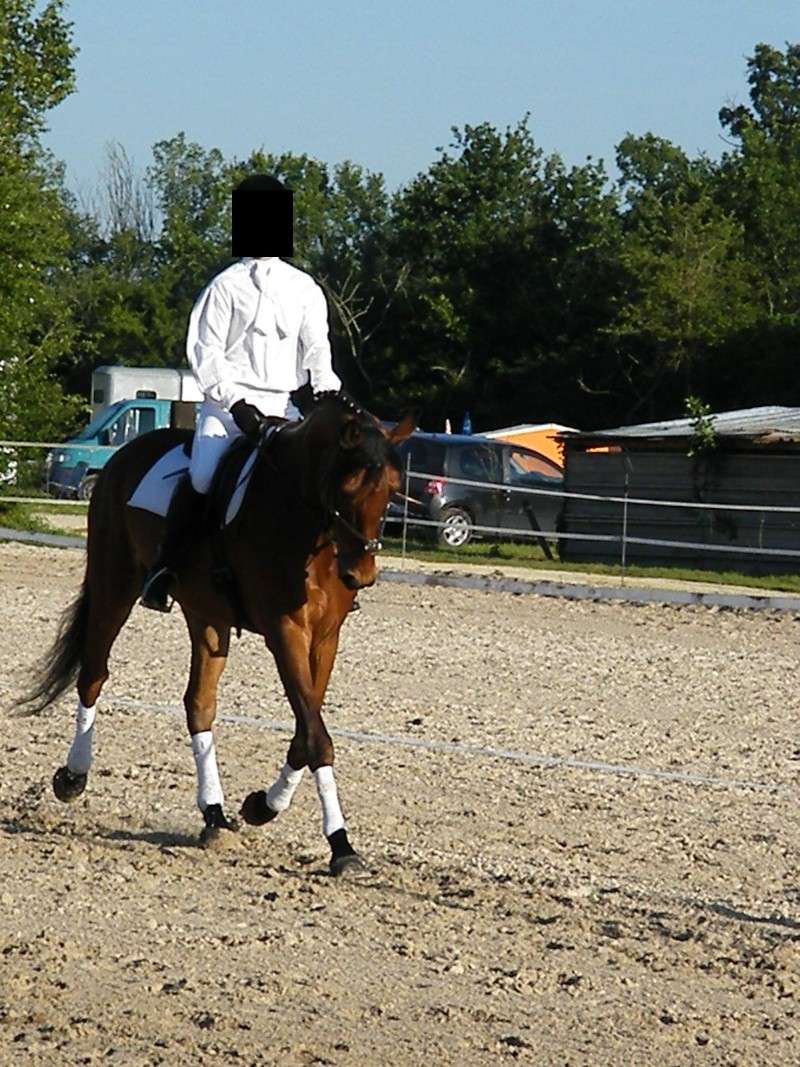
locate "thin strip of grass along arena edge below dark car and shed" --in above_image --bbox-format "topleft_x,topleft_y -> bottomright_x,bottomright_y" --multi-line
383,537 -> 800,593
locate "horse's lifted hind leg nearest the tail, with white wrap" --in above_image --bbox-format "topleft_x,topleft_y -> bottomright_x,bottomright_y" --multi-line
52,561 -> 139,802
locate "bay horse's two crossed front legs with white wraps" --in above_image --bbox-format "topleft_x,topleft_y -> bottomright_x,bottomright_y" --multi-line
242,624 -> 364,875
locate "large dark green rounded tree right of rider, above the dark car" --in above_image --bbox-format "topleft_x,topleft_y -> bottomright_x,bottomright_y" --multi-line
372,117 -> 615,427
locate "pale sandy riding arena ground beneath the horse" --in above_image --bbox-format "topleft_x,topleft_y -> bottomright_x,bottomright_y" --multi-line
0,545 -> 800,1067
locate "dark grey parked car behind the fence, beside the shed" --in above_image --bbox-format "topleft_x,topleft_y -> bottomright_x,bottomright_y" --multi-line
386,433 -> 563,548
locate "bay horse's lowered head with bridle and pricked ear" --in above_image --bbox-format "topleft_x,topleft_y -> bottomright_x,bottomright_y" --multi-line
306,394 -> 414,590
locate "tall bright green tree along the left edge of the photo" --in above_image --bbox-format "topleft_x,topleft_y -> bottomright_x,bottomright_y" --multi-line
0,0 -> 82,439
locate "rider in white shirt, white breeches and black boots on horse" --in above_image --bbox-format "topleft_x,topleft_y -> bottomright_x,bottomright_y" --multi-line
141,174 -> 341,611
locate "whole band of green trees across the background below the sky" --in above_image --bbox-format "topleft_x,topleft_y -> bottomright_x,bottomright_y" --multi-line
0,24 -> 800,437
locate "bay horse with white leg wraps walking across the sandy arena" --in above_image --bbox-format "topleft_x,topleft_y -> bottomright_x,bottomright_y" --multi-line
26,394 -> 414,875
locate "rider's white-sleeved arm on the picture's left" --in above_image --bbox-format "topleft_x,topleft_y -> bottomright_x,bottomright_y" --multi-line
186,283 -> 243,411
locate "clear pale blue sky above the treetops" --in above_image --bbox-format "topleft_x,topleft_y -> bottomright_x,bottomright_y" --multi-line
46,0 -> 800,191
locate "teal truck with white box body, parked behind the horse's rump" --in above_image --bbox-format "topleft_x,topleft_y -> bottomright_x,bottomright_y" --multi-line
45,367 -> 201,500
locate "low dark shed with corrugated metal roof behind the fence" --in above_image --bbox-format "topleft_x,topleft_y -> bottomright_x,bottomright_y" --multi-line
560,407 -> 800,574
